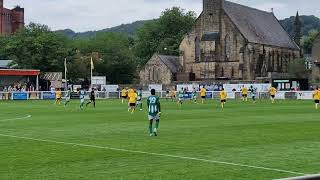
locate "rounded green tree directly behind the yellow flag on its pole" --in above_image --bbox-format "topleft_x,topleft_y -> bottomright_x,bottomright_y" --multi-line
74,32 -> 137,84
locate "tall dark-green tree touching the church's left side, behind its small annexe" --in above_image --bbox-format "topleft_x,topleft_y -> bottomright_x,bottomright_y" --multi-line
134,7 -> 196,65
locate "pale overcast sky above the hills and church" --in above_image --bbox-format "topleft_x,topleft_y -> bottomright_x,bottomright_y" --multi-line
4,0 -> 320,32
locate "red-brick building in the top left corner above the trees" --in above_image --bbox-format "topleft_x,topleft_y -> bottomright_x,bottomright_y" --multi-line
0,0 -> 24,35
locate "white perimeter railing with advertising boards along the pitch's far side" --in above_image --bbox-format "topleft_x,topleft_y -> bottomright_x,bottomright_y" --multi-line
0,91 -> 313,100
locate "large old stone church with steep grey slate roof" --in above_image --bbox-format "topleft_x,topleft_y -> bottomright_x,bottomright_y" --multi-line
140,0 -> 300,84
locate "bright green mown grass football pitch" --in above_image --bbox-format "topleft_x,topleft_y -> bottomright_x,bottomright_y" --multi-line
0,100 -> 320,180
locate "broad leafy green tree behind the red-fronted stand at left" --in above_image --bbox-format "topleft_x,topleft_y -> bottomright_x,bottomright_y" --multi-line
3,23 -> 74,72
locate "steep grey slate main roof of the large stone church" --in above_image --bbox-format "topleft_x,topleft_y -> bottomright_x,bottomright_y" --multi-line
223,1 -> 299,49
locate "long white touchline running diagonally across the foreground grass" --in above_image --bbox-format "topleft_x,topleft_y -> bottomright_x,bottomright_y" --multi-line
0,134 -> 306,175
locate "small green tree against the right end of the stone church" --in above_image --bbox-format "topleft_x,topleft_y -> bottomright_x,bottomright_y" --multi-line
288,59 -> 310,79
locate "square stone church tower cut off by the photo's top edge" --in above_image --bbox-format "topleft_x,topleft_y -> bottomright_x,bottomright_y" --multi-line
203,0 -> 224,32
